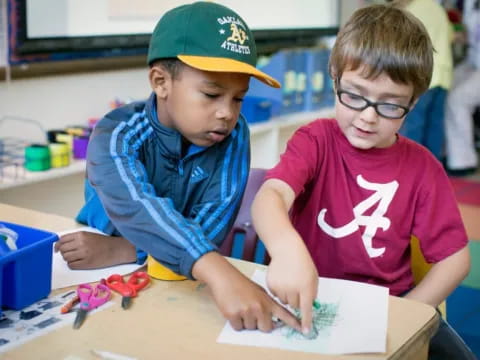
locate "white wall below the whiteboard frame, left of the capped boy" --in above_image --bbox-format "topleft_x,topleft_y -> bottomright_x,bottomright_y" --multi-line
0,67 -> 151,142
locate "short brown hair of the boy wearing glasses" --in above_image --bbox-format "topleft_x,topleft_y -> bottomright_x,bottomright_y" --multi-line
329,5 -> 433,99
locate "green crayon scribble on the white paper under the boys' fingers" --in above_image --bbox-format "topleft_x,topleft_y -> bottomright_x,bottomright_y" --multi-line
283,300 -> 338,340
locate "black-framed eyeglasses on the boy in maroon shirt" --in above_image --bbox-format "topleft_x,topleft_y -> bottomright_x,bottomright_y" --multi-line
337,89 -> 410,119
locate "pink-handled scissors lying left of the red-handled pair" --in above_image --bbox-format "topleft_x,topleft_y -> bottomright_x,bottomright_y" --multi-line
73,284 -> 111,329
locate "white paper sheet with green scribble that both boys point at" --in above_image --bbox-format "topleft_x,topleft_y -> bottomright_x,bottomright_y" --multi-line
217,270 -> 388,354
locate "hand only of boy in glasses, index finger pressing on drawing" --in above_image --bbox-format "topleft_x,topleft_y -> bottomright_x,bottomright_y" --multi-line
267,242 -> 318,334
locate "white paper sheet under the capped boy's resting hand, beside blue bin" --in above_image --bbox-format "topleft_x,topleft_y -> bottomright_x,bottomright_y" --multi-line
52,227 -> 143,290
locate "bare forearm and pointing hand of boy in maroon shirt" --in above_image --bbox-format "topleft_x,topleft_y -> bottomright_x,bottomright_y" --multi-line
252,179 -> 318,335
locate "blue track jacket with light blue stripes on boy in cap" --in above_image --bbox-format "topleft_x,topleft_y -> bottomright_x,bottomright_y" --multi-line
77,94 -> 250,278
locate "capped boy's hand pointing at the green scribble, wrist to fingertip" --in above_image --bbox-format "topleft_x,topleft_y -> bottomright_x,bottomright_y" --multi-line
192,252 -> 300,332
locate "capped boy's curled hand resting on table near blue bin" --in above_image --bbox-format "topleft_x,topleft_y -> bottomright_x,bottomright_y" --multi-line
54,231 -> 137,270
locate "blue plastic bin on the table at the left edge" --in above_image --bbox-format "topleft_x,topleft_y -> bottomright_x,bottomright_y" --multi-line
0,221 -> 58,315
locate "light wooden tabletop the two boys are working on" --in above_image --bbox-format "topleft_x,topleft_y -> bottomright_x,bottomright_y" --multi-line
0,204 -> 439,360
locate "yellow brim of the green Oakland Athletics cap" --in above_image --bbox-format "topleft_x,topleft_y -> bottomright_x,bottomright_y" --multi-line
177,55 -> 281,88
